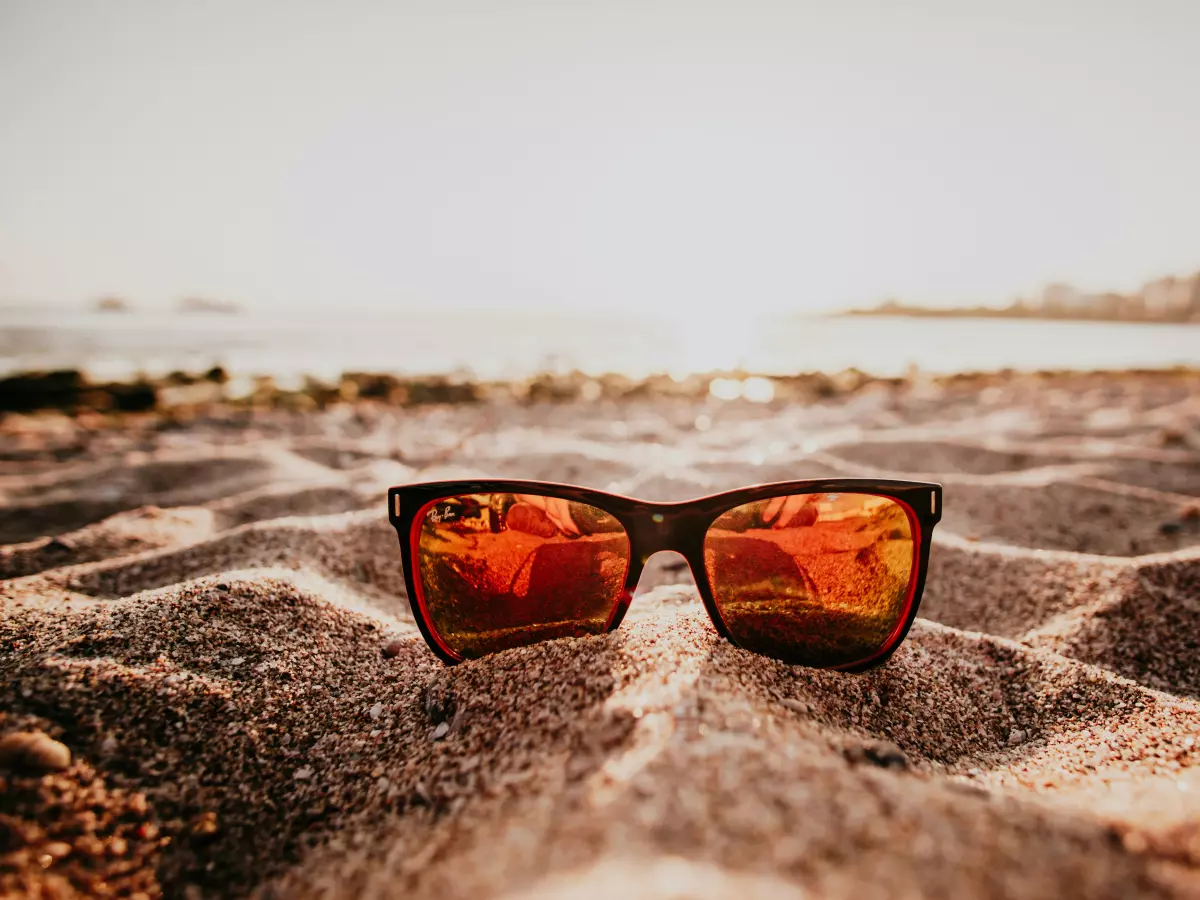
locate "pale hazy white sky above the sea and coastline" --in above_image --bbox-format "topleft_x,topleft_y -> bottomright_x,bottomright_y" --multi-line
0,0 -> 1200,313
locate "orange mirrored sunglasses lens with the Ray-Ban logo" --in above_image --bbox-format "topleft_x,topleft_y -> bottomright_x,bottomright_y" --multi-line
416,493 -> 630,658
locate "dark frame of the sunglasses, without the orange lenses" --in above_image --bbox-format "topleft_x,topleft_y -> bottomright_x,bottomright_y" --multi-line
388,478 -> 942,672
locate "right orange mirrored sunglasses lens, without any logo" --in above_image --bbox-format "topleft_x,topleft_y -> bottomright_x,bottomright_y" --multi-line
704,493 -> 916,666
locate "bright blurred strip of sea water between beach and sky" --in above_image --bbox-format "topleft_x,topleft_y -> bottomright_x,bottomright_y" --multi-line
0,308 -> 1200,379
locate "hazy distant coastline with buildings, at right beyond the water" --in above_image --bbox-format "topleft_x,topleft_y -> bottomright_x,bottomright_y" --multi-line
842,272 -> 1200,324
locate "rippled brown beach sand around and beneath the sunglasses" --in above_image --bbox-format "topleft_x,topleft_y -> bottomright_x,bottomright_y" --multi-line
0,373 -> 1200,900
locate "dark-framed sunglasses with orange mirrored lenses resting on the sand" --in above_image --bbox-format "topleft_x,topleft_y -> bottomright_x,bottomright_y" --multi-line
388,479 -> 942,671
